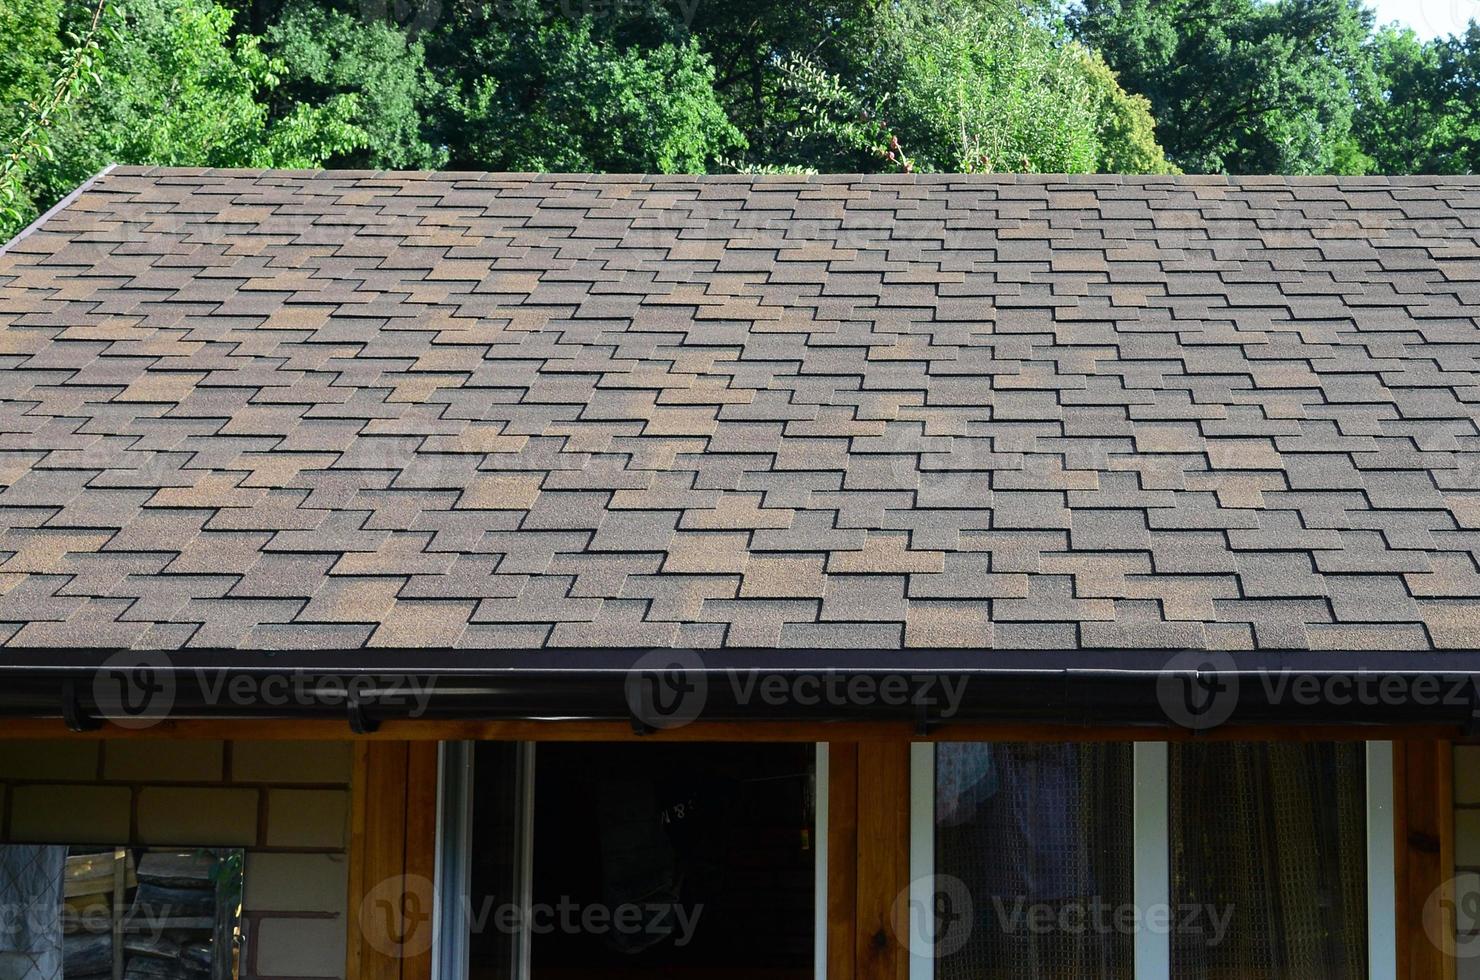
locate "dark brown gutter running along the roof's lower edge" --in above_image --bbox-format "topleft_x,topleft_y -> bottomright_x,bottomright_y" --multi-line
0,648 -> 1480,731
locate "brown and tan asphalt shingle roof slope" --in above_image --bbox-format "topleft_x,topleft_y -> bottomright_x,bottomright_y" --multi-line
0,169 -> 1480,650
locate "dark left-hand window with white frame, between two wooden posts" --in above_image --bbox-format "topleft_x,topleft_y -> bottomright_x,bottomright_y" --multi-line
437,743 -> 826,980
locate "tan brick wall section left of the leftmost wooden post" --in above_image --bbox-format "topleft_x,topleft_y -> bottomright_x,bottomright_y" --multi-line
0,739 -> 351,980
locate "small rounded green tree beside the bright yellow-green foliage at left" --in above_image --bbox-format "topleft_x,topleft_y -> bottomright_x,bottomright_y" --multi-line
263,3 -> 447,170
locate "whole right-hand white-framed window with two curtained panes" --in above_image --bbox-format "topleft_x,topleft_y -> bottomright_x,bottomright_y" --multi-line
910,740 -> 1396,980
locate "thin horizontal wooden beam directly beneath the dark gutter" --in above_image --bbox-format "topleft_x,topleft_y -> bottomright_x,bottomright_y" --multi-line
0,718 -> 1459,742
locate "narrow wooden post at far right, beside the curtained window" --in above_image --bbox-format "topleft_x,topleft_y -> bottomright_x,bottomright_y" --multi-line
1393,739 -> 1455,980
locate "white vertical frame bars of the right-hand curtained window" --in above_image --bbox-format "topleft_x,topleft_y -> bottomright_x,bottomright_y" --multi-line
909,742 -> 1397,980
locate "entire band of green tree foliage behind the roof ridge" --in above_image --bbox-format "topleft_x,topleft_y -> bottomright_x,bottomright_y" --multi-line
0,0 -> 1480,241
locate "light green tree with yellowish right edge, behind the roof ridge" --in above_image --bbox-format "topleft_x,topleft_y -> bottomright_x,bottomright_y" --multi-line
783,0 -> 1168,173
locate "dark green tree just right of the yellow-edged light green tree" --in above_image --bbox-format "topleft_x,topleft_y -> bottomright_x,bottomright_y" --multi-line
1072,0 -> 1376,173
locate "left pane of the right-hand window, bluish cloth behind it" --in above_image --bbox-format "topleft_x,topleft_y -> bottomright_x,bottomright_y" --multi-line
934,742 -> 1134,980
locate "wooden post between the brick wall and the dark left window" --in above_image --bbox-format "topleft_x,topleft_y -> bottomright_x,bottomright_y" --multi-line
345,742 -> 437,980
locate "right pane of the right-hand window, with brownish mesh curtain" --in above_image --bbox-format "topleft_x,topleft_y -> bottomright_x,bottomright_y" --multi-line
1168,742 -> 1368,980
